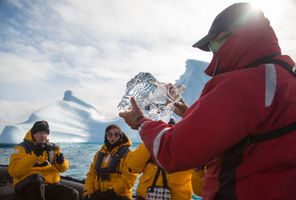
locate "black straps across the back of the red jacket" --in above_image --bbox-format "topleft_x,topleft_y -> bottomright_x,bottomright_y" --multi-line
214,54 -> 296,200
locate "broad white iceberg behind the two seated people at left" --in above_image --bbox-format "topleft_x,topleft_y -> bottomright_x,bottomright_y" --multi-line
0,90 -> 139,144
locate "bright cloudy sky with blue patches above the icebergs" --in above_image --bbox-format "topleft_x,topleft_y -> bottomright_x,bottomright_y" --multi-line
0,0 -> 296,131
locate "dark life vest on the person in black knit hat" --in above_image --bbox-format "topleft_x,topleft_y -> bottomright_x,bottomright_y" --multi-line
19,140 -> 57,167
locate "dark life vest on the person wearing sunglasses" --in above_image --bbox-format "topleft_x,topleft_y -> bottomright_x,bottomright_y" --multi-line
95,146 -> 130,176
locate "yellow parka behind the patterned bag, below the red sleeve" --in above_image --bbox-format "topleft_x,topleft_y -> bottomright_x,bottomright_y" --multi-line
127,143 -> 192,200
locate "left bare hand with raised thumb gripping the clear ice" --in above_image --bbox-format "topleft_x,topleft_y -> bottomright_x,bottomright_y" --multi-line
119,97 -> 144,129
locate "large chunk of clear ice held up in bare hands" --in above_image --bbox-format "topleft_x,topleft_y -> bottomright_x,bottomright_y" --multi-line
118,72 -> 185,122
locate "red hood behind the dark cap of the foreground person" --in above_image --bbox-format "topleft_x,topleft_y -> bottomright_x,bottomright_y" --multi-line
205,15 -> 281,76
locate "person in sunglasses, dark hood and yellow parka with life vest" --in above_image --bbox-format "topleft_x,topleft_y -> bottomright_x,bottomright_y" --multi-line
83,124 -> 137,200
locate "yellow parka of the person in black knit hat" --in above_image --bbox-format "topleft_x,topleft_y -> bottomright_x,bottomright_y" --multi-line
8,130 -> 69,186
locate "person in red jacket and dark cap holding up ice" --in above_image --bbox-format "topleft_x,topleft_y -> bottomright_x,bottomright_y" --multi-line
119,3 -> 296,200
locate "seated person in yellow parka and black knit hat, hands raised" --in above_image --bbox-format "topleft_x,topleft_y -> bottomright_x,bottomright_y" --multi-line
8,121 -> 79,200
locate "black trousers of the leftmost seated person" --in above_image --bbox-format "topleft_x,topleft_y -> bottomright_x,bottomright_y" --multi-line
15,174 -> 79,200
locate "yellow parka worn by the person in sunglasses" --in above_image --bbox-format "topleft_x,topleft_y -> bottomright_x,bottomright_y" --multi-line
83,134 -> 137,199
